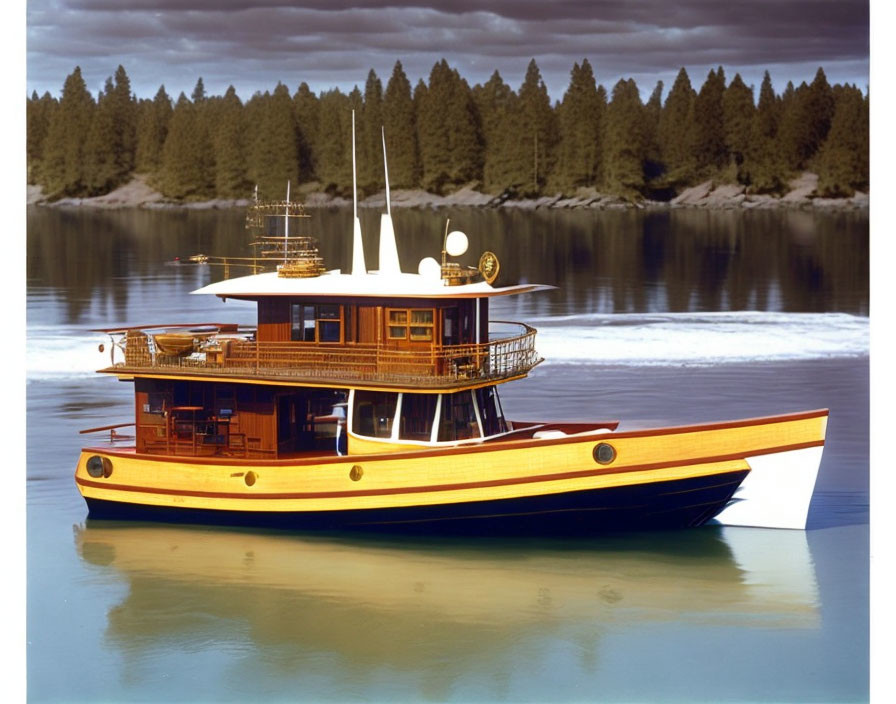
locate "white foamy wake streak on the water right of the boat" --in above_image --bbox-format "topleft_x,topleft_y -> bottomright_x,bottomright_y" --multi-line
531,311 -> 869,366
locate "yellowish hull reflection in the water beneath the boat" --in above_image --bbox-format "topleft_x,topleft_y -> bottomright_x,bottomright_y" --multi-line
76,521 -> 820,676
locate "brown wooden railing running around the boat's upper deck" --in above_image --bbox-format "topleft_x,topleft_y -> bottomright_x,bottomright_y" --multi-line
109,321 -> 541,387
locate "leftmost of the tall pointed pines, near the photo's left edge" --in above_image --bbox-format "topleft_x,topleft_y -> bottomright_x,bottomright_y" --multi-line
42,67 -> 96,196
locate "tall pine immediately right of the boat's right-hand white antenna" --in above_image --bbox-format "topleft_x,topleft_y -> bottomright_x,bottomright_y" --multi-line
383,61 -> 420,188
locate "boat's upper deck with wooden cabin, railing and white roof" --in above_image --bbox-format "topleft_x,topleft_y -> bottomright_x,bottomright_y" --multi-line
101,203 -> 544,391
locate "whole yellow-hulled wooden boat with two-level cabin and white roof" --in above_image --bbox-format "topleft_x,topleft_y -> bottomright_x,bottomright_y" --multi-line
75,121 -> 828,533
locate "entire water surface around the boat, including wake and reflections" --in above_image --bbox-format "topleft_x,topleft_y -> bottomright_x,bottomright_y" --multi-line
26,209 -> 869,702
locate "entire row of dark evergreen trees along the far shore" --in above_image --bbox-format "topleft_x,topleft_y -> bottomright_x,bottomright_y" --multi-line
27,59 -> 869,200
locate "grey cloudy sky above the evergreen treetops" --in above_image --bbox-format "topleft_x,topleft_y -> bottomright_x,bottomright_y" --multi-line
26,0 -> 869,100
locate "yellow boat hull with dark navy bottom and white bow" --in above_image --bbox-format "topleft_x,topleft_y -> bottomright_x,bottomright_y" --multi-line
75,411 -> 827,533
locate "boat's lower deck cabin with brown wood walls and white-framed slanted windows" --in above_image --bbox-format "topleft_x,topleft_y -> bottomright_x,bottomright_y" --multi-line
134,377 -> 508,459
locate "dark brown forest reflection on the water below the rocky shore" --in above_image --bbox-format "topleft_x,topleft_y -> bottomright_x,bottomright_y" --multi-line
28,208 -> 868,322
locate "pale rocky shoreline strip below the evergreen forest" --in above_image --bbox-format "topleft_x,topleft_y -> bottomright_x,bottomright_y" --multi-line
28,172 -> 869,210
